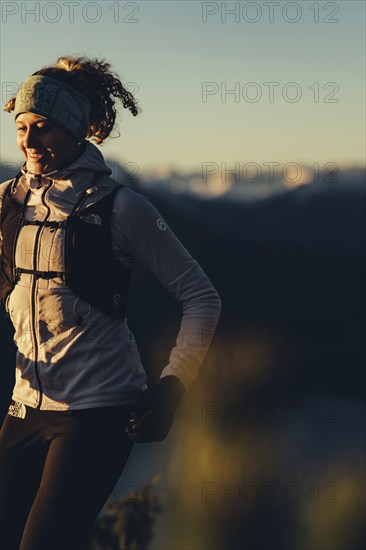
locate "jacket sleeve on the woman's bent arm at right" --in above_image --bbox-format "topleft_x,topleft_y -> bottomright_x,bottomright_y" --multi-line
111,188 -> 221,389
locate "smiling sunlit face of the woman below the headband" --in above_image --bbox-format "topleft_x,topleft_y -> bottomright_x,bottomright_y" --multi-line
15,113 -> 80,174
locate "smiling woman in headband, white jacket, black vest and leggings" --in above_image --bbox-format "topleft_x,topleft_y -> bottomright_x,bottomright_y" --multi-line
0,57 -> 221,550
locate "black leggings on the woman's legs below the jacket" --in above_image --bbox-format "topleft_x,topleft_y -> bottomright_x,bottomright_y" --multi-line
0,406 -> 133,550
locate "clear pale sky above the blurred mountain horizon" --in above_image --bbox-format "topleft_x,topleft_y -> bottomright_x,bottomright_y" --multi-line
0,0 -> 365,177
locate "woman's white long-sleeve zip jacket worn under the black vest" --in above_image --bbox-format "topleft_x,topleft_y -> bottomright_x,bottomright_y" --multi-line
0,141 -> 221,410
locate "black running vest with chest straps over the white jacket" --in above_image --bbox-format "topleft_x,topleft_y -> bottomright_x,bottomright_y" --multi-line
0,173 -> 131,319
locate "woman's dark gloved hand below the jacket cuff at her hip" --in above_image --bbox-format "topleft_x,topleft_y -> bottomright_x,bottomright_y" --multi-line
125,376 -> 185,443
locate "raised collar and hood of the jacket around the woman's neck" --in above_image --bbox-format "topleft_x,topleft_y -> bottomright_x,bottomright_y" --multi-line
21,140 -> 112,190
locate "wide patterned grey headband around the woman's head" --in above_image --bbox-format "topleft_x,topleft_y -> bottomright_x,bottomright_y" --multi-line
14,75 -> 91,141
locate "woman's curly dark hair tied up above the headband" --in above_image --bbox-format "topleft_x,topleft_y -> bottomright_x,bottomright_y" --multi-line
4,56 -> 141,145
